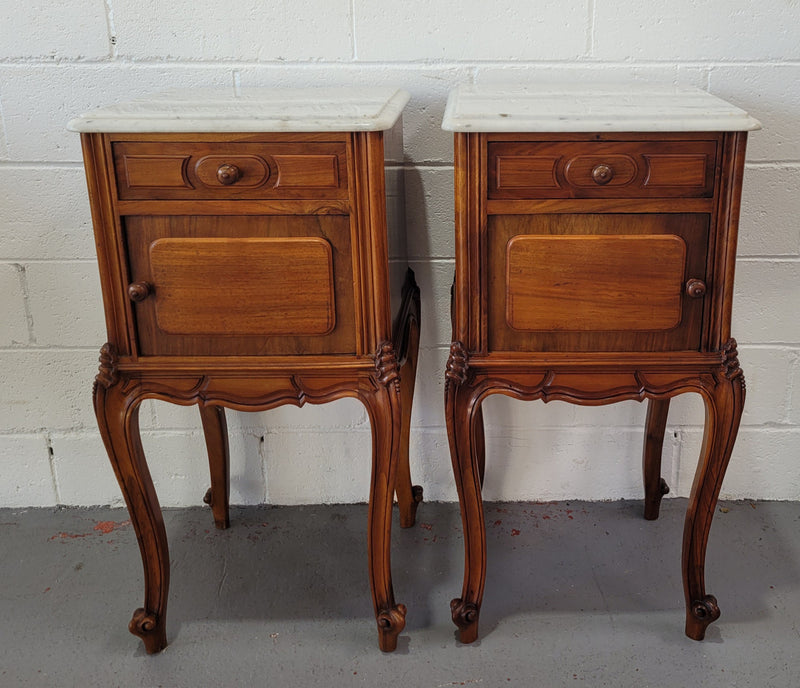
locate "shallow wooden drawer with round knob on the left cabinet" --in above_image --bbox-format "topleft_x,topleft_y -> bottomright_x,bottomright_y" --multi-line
112,141 -> 347,200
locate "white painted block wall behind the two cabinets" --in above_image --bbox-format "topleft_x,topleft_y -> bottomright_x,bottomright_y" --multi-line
0,0 -> 800,506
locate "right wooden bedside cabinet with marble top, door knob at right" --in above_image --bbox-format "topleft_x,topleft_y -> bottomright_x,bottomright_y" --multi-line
443,86 -> 760,643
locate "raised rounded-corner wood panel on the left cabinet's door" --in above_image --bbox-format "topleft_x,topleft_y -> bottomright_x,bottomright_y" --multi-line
149,237 -> 335,336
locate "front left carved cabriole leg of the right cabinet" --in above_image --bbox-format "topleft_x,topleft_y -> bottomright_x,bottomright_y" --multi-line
445,342 -> 486,643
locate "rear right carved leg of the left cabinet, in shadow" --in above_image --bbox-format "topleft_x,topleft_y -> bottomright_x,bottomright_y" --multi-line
394,270 -> 422,528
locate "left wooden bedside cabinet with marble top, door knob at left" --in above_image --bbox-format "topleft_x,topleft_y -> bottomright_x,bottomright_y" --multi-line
70,89 -> 422,653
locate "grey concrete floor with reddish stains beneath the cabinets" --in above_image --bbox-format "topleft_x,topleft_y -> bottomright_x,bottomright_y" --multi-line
0,499 -> 800,688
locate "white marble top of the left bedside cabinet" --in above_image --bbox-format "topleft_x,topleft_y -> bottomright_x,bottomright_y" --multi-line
67,88 -> 409,133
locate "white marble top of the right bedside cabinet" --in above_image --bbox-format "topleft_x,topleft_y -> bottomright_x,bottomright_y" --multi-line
442,83 -> 761,132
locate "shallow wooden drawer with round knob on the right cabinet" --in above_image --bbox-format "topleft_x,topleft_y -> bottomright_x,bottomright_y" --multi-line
488,140 -> 717,199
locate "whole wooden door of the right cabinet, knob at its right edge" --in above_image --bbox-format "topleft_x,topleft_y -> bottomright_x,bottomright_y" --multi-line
487,213 -> 709,352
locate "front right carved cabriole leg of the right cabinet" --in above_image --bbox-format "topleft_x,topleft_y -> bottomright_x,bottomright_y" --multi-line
683,340 -> 745,640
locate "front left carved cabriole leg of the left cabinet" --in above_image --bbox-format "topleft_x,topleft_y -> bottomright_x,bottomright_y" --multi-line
93,344 -> 169,653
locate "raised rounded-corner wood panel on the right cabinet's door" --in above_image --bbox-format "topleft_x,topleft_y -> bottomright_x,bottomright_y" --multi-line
506,235 -> 686,331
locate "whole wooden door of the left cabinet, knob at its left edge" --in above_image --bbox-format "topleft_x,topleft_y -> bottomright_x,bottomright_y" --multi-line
123,215 -> 356,356
